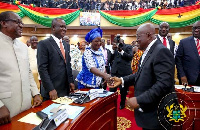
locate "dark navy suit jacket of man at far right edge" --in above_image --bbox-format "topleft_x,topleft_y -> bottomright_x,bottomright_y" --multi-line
175,36 -> 200,85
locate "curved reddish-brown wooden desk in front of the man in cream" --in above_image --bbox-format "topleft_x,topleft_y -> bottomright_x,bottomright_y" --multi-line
0,92 -> 118,130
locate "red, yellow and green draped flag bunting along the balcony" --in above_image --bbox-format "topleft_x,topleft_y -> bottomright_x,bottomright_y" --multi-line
0,1 -> 200,28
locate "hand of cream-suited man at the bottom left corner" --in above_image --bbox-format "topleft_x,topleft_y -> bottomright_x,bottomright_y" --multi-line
0,106 -> 11,125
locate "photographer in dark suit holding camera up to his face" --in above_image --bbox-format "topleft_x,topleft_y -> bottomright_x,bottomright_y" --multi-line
110,36 -> 133,109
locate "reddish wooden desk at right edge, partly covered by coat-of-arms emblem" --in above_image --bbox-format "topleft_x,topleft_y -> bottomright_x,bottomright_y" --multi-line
176,89 -> 200,130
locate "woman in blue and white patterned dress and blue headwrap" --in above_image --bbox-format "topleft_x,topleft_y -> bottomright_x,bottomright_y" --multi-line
76,28 -> 110,89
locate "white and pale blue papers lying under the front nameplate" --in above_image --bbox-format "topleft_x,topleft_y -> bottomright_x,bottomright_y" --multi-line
42,103 -> 85,119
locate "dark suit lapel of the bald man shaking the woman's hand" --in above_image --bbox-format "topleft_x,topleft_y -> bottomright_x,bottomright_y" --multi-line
135,40 -> 160,81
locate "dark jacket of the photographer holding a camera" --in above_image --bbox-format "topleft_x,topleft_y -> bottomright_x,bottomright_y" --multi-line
110,44 -> 133,76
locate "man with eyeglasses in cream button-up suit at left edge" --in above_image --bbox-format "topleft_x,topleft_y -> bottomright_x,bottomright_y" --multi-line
0,11 -> 42,125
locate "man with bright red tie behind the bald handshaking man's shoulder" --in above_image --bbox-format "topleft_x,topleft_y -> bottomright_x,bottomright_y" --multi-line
157,22 -> 175,55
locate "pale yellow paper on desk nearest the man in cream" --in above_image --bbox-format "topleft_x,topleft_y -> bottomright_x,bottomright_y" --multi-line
18,112 -> 42,125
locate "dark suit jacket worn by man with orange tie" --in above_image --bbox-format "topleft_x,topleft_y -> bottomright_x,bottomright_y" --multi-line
37,37 -> 73,98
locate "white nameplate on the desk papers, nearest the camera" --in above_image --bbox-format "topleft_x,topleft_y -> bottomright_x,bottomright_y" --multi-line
54,109 -> 68,126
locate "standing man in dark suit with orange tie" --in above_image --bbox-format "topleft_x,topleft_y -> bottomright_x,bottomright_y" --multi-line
37,18 -> 75,100
